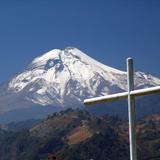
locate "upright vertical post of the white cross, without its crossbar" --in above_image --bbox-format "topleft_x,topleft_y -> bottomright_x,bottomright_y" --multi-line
127,58 -> 137,160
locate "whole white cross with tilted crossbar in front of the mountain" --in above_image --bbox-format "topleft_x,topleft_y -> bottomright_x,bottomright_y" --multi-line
84,58 -> 160,160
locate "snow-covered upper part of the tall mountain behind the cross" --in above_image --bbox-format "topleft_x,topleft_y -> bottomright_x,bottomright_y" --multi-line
8,47 -> 160,106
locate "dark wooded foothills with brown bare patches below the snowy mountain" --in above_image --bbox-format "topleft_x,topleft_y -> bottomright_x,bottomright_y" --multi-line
0,109 -> 160,160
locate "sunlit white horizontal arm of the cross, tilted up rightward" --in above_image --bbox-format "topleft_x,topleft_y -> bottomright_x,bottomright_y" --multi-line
84,86 -> 160,105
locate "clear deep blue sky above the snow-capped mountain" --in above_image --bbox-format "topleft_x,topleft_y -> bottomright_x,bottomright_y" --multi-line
0,0 -> 160,82
